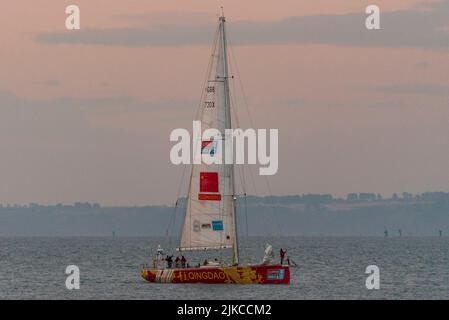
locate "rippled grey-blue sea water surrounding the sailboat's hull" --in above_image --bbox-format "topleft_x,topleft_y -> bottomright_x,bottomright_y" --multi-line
0,237 -> 449,299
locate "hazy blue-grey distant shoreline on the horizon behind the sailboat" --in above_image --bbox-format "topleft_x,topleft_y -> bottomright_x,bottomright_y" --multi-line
0,192 -> 449,237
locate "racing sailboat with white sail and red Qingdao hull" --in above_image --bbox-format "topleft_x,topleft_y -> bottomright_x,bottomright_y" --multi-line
141,15 -> 290,284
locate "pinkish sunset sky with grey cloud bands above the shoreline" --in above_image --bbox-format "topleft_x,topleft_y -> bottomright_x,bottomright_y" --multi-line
0,0 -> 449,205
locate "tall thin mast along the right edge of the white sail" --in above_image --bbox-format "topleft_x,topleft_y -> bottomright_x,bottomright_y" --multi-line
220,13 -> 239,264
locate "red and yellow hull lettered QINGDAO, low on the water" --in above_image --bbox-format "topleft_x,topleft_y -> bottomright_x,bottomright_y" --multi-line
141,265 -> 290,284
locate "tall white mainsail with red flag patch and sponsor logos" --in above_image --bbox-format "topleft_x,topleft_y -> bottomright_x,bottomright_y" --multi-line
178,16 -> 238,263
